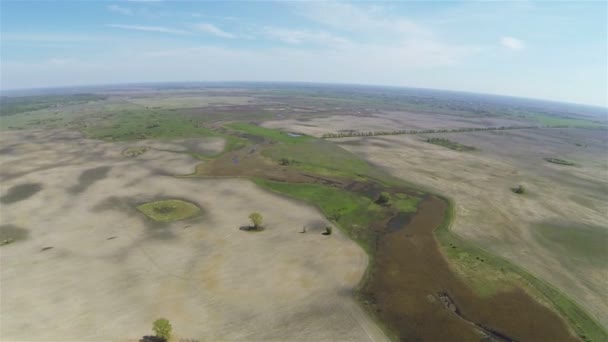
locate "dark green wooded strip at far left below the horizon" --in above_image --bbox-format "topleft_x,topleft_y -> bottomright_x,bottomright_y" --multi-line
0,94 -> 106,116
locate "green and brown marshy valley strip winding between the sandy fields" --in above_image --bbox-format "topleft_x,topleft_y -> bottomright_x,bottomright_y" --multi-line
196,125 -> 601,341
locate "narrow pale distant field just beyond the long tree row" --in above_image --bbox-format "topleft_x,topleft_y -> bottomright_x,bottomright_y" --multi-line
262,112 -> 530,137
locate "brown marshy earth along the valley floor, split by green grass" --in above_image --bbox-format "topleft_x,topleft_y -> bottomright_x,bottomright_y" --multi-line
196,137 -> 577,341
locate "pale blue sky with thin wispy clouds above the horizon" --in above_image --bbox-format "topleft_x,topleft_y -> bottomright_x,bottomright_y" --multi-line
0,0 -> 608,107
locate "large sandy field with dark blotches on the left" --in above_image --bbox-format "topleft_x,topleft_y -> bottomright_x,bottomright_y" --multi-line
0,131 -> 384,341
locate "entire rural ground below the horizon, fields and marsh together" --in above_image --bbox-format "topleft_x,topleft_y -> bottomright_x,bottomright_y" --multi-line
0,84 -> 608,341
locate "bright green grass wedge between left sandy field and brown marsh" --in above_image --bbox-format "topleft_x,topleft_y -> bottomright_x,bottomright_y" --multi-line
255,179 -> 387,253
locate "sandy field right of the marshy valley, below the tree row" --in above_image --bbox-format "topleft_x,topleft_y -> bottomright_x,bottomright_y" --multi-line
332,129 -> 608,326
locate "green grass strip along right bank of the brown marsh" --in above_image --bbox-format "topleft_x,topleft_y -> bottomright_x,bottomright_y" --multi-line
435,196 -> 608,341
